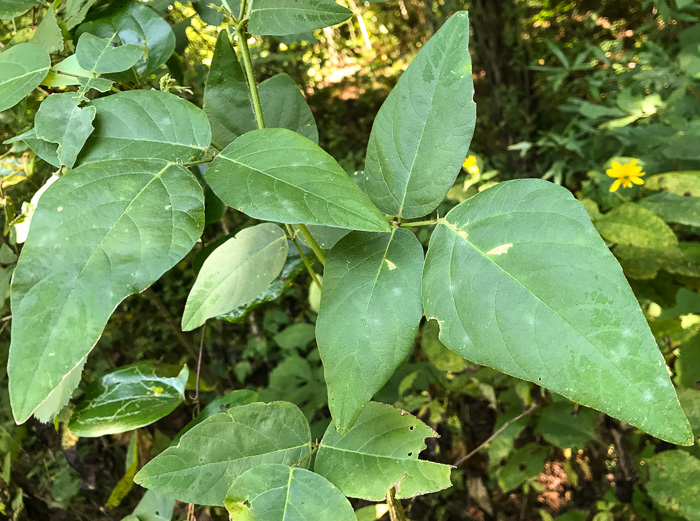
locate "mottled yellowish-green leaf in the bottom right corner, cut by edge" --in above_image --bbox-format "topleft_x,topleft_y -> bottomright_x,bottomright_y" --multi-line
646,450 -> 700,521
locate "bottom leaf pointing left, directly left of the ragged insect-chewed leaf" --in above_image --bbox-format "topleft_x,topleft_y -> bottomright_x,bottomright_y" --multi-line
134,402 -> 311,506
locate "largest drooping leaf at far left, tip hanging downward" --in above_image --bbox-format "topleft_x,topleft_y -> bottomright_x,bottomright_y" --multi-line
8,159 -> 204,422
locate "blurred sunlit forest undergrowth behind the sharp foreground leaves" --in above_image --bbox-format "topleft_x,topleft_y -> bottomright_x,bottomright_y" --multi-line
0,0 -> 700,521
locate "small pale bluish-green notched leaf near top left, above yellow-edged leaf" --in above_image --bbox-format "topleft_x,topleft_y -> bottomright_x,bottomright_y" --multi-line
75,33 -> 143,74
